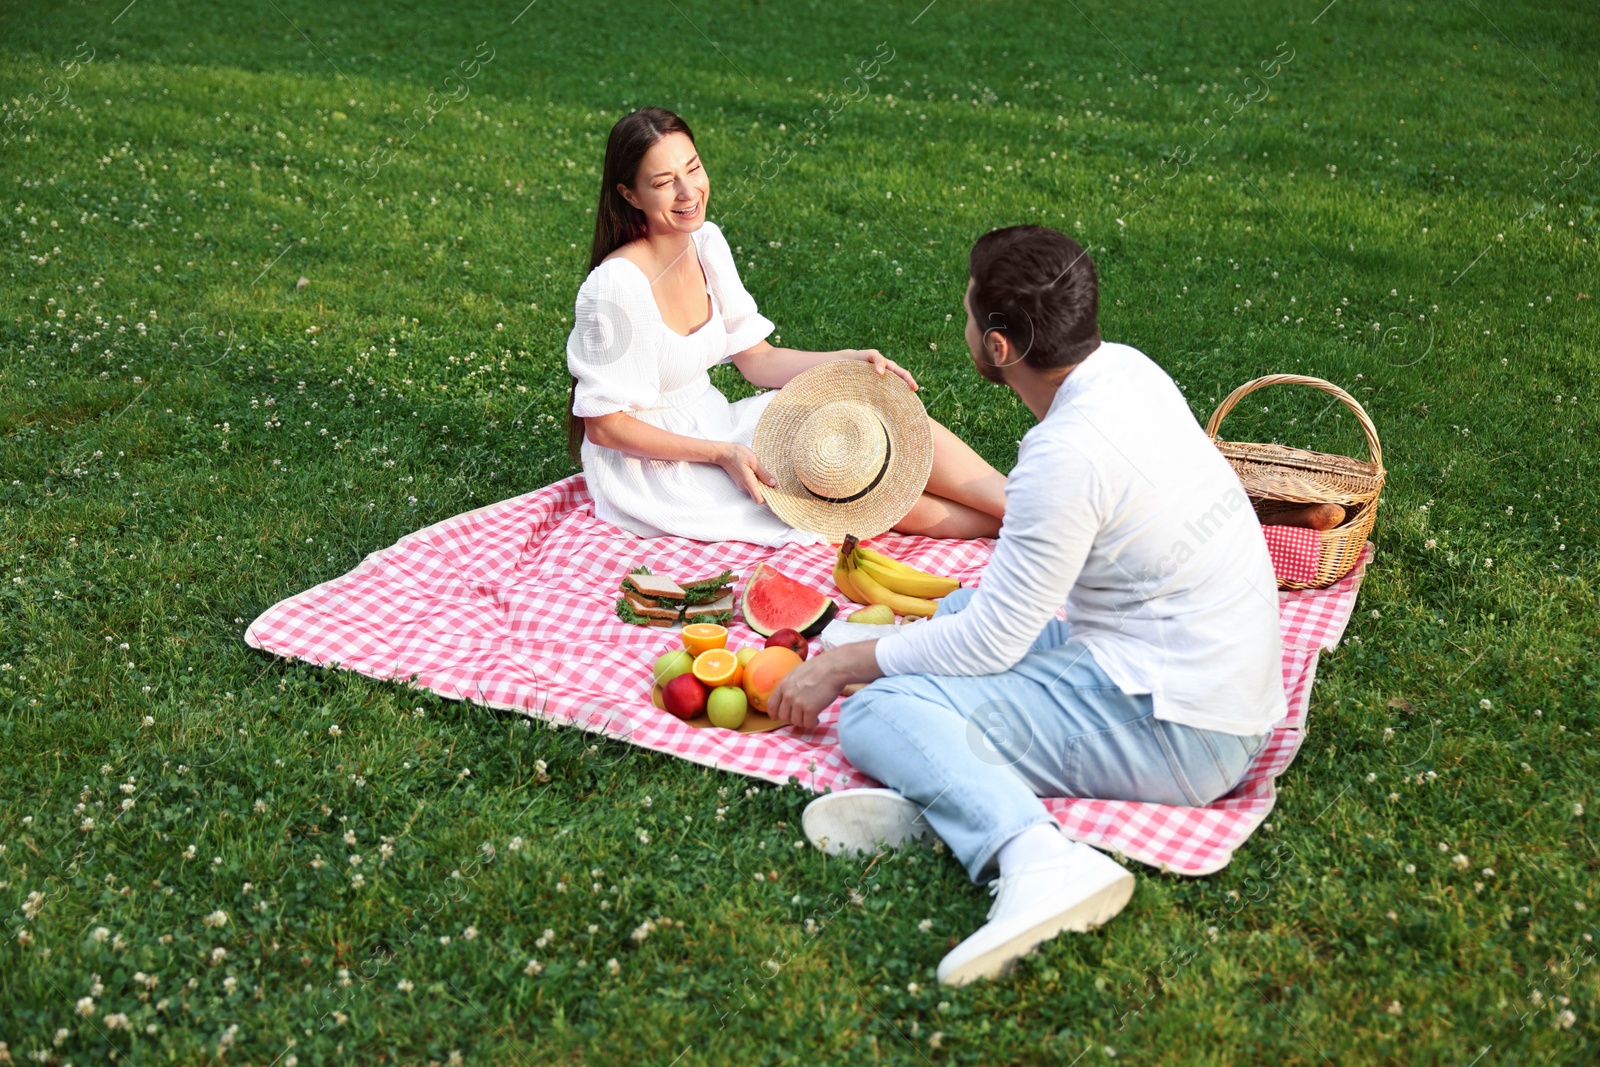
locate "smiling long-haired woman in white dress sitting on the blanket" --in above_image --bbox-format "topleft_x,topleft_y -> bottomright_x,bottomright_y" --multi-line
566,107 -> 1005,545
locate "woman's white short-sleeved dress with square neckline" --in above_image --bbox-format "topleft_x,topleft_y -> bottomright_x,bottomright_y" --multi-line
566,222 -> 826,545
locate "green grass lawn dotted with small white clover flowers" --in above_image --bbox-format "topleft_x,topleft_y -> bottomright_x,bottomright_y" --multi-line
0,0 -> 1600,1067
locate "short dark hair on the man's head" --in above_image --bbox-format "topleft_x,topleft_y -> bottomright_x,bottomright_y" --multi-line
968,226 -> 1101,370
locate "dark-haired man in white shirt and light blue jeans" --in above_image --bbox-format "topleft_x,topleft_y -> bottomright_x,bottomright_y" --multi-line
770,226 -> 1286,984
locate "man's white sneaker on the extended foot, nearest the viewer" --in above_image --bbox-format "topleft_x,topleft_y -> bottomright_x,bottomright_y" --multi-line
939,843 -> 1133,985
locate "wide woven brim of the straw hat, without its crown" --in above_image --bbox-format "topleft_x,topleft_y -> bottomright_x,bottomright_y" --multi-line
750,360 -> 933,544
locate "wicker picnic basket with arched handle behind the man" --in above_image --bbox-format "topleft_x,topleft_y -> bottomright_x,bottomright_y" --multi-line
1205,374 -> 1384,589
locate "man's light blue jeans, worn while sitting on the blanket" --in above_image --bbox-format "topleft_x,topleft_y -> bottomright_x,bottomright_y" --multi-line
838,589 -> 1269,881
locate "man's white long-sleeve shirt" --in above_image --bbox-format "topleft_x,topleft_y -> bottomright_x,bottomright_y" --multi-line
877,344 -> 1286,734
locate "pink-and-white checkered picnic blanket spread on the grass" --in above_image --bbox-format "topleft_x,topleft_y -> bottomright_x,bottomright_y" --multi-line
245,475 -> 1371,875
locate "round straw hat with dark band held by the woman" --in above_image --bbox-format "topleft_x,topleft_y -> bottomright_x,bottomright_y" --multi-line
750,360 -> 933,544
